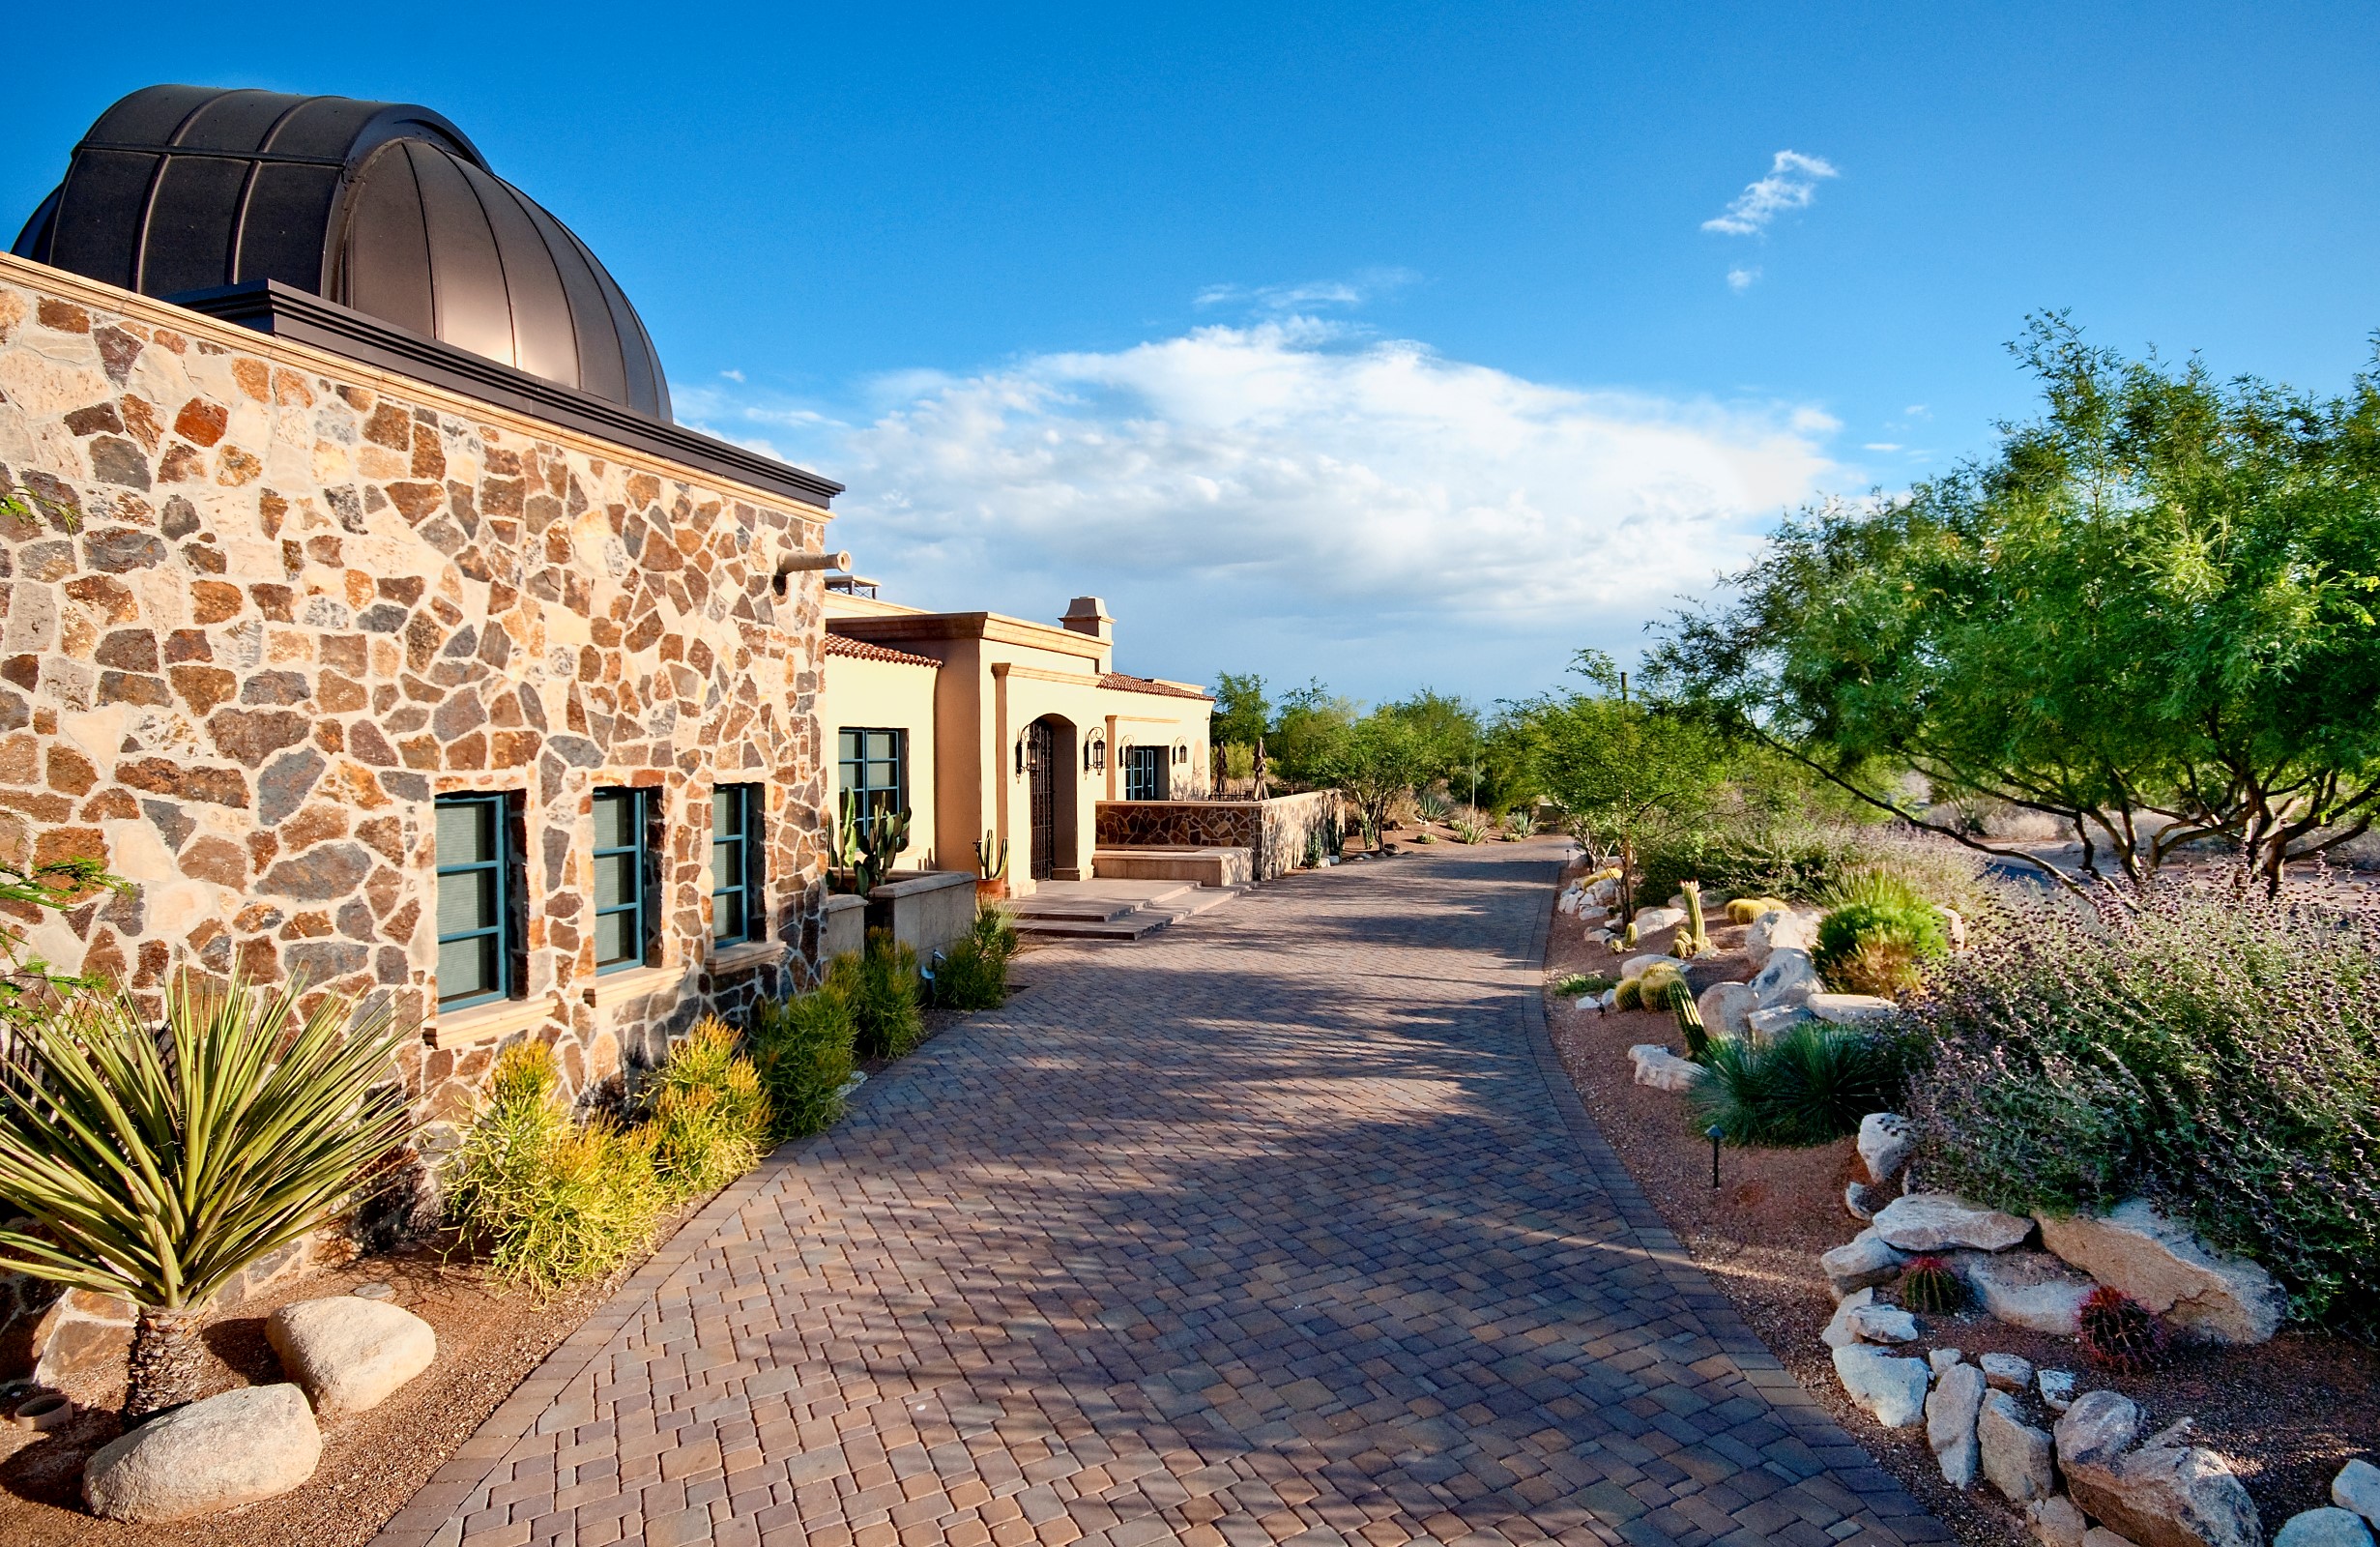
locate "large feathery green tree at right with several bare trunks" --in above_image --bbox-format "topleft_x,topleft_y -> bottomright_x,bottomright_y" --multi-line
1652,314 -> 2380,888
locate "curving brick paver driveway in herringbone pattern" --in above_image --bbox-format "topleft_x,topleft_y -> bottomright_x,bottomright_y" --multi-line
383,842 -> 1947,1547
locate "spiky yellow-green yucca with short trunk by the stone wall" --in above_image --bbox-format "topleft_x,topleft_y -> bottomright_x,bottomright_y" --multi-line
0,974 -> 414,1423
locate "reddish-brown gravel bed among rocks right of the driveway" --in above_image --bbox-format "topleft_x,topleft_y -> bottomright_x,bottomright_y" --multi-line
1545,857 -> 2380,1547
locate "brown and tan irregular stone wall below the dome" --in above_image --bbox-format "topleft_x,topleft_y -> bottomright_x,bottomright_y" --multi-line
0,259 -> 824,1133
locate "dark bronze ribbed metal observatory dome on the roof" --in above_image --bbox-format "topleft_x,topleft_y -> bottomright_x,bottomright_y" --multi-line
15,86 -> 671,422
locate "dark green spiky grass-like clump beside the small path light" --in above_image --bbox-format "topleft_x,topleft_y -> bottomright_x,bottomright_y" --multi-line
1690,1021 -> 1901,1147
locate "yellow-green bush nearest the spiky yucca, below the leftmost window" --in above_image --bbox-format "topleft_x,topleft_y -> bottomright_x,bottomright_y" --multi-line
445,1040 -> 666,1293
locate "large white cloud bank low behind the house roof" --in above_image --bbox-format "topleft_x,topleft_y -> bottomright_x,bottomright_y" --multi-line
692,316 -> 1838,695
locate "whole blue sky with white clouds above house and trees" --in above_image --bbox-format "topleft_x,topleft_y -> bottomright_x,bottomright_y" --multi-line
0,2 -> 2380,700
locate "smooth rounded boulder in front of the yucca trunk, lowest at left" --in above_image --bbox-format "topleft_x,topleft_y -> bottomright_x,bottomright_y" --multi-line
83,1386 -> 321,1523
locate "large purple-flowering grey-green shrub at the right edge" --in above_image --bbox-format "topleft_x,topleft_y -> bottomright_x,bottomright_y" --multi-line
1909,886 -> 2380,1337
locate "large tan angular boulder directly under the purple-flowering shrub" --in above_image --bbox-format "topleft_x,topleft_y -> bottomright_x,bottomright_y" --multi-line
2042,1197 -> 2289,1342
